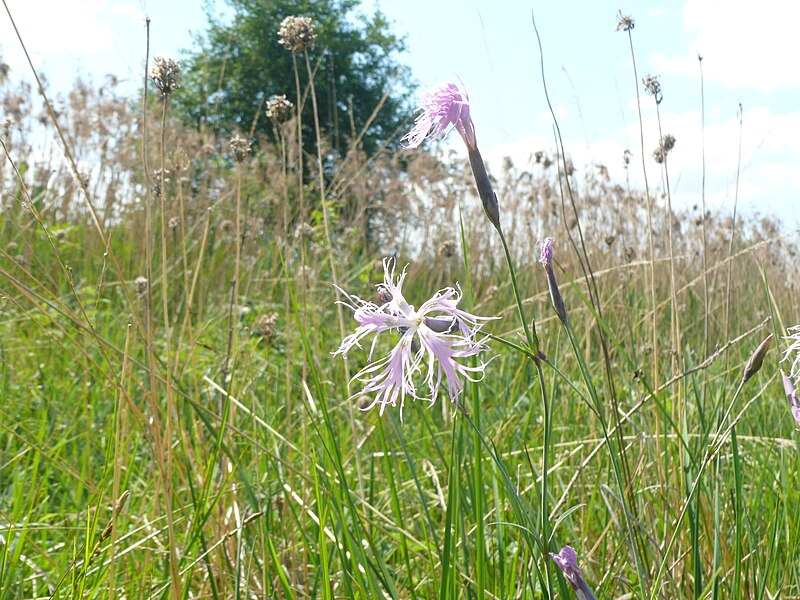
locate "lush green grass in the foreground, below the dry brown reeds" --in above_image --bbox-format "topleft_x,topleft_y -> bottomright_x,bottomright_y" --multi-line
0,193 -> 800,598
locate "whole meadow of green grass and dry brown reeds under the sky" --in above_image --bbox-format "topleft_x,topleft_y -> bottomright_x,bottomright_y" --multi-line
0,14 -> 800,599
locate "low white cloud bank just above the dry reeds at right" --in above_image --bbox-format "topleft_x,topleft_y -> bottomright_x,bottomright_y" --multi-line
484,106 -> 800,227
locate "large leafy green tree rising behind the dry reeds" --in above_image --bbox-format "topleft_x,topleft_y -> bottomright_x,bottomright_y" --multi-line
174,0 -> 410,153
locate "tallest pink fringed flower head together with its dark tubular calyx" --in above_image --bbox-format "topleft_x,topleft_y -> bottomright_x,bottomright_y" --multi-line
400,83 -> 500,231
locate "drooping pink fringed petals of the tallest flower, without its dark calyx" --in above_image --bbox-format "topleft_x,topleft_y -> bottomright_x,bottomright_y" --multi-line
401,83 -> 477,150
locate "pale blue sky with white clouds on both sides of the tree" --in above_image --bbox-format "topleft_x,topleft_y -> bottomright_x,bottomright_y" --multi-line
0,0 -> 800,227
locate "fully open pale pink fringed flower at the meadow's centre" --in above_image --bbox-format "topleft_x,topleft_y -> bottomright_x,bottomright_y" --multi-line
334,258 -> 494,420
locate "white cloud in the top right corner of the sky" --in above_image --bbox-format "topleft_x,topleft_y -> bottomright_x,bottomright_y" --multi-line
653,0 -> 800,91
